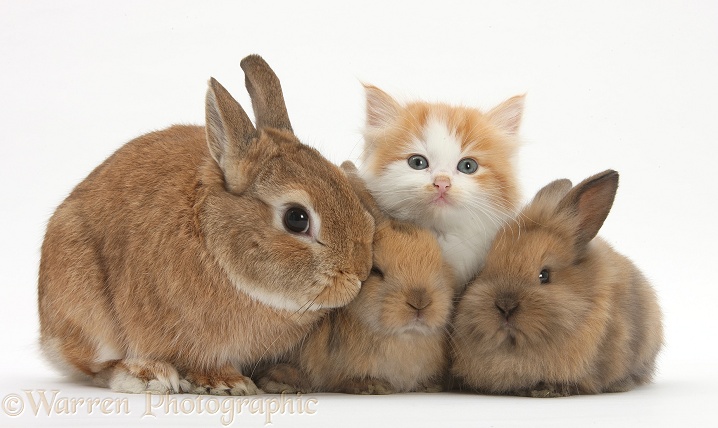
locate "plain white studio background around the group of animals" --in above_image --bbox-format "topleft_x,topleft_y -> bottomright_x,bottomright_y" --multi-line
0,0 -> 718,426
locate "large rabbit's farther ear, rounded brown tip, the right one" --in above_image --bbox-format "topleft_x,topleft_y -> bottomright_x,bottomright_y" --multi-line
240,55 -> 293,132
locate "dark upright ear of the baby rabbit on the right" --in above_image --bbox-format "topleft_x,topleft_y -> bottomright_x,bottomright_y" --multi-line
557,169 -> 618,252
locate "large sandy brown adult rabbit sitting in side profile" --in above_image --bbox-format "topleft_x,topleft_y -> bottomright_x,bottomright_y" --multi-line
39,55 -> 374,395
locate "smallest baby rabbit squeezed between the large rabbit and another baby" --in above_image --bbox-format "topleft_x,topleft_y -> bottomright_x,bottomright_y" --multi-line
259,162 -> 455,394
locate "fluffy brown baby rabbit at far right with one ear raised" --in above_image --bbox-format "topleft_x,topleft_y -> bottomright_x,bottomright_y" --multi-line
451,170 -> 663,397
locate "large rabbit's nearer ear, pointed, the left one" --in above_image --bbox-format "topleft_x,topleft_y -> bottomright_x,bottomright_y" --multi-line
205,78 -> 257,191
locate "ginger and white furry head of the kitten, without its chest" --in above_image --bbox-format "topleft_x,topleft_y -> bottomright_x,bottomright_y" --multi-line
361,85 -> 524,226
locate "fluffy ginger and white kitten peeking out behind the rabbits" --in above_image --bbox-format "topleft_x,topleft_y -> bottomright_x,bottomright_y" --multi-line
361,85 -> 524,289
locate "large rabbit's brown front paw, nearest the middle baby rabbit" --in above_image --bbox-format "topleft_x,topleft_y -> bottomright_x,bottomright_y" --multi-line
180,366 -> 262,395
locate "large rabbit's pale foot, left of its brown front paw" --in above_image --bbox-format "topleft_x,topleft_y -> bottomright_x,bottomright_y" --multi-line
95,359 -> 180,394
